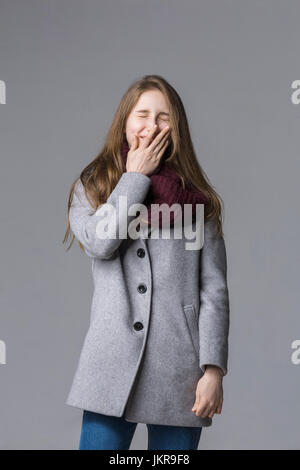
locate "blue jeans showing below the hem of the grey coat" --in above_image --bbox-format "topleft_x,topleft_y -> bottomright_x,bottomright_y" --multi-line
78,410 -> 202,450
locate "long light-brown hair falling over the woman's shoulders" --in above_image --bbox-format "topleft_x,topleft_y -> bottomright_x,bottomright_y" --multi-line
63,75 -> 224,250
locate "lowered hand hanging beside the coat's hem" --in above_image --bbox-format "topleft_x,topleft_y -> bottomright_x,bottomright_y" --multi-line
192,367 -> 223,418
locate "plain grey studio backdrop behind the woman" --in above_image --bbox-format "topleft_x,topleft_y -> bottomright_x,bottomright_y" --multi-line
0,0 -> 300,449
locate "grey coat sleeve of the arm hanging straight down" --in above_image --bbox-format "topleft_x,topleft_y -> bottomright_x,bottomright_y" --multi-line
199,219 -> 229,375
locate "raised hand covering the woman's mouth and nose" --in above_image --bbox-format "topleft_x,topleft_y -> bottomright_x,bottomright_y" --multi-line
126,126 -> 170,176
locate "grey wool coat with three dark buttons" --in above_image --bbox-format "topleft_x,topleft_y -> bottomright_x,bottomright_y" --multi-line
65,172 -> 229,427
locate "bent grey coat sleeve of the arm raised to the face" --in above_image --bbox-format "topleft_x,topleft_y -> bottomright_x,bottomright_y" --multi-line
69,171 -> 151,259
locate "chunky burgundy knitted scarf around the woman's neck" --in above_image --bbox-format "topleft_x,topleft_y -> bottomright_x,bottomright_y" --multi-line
122,138 -> 207,228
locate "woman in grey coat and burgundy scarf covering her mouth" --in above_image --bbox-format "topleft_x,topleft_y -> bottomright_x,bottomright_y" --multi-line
64,75 -> 229,450
